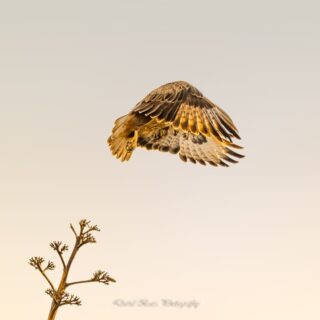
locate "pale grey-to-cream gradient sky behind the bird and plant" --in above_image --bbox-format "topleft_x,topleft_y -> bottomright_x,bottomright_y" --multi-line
0,0 -> 320,320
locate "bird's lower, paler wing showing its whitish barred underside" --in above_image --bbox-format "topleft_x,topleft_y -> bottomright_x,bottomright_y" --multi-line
138,126 -> 243,167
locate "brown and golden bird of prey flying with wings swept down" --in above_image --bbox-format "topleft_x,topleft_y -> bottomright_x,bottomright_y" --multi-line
108,81 -> 243,167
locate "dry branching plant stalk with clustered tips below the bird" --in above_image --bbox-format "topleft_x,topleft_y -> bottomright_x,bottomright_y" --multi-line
29,220 -> 116,320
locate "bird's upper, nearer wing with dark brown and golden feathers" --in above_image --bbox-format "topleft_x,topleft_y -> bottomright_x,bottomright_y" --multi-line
133,81 -> 240,143
